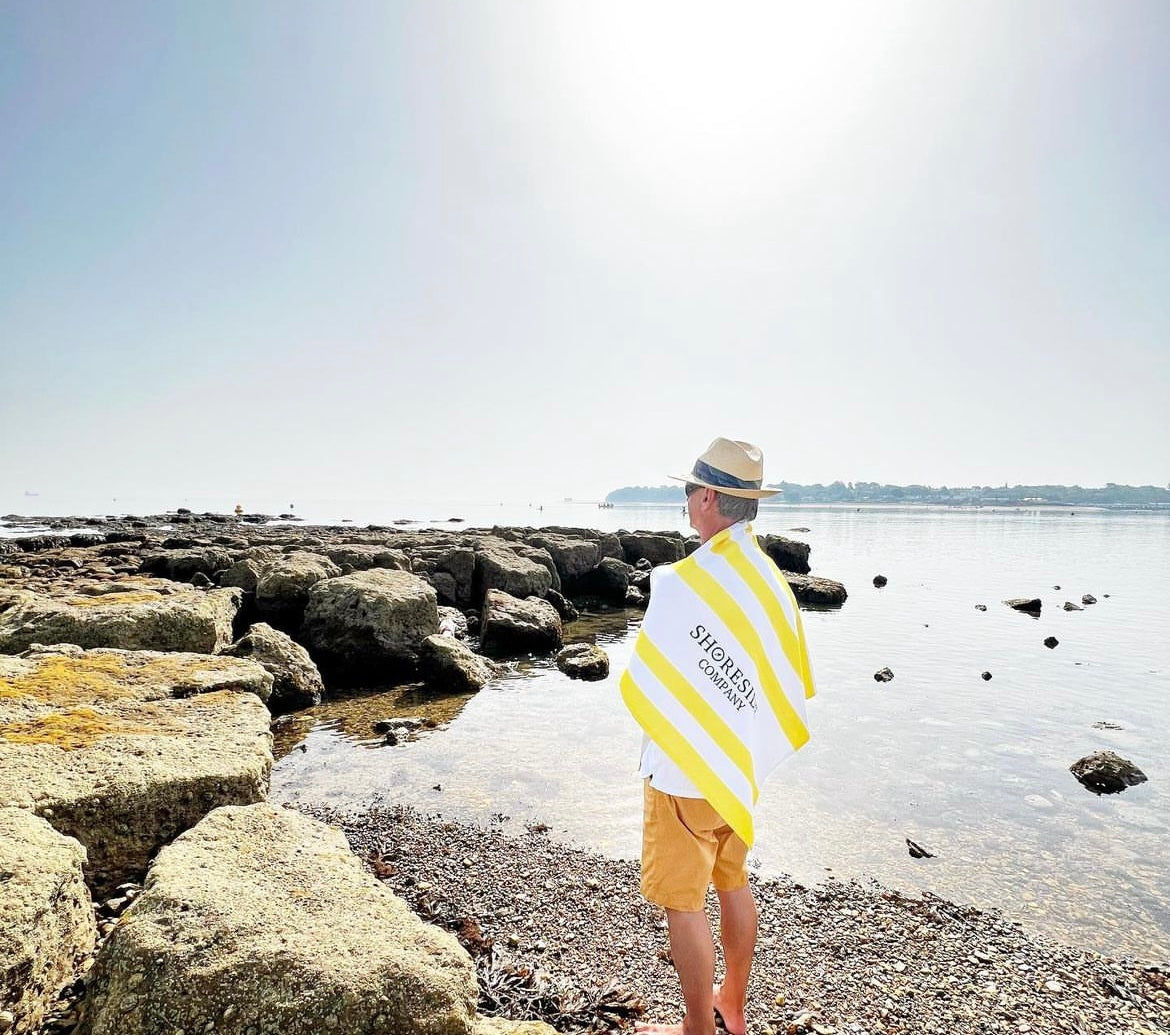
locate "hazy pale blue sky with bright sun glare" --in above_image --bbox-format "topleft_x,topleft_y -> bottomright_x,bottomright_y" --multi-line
0,0 -> 1170,506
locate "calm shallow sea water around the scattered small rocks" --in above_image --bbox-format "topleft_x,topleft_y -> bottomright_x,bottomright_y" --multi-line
244,508 -> 1170,960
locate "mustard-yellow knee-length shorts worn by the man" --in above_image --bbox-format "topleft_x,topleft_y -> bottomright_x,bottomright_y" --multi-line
642,780 -> 748,912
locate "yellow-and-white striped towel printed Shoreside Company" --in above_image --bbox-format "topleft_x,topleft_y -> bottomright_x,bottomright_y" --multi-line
621,523 -> 815,847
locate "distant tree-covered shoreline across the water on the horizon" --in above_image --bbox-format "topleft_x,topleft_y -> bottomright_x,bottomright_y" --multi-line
605,482 -> 1170,510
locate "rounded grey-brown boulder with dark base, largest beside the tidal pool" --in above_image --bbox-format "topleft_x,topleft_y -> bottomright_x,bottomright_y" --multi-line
300,568 -> 439,682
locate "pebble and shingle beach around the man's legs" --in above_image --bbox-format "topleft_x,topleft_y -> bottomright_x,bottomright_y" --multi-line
304,807 -> 1170,1035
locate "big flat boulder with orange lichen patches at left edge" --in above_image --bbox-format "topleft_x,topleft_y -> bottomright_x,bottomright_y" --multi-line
0,646 -> 273,893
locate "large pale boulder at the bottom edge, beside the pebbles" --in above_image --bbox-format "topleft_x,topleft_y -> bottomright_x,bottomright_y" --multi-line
77,803 -> 476,1035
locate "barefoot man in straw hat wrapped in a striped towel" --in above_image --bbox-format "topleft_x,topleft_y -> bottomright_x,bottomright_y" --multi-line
621,439 -> 814,1035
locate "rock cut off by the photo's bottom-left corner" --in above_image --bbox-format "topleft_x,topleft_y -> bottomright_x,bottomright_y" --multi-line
0,807 -> 97,1031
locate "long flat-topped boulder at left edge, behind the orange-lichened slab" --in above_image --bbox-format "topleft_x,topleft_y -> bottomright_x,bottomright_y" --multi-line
0,584 -> 241,654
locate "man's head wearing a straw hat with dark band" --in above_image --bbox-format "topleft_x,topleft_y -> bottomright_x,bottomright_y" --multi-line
672,439 -> 779,543
